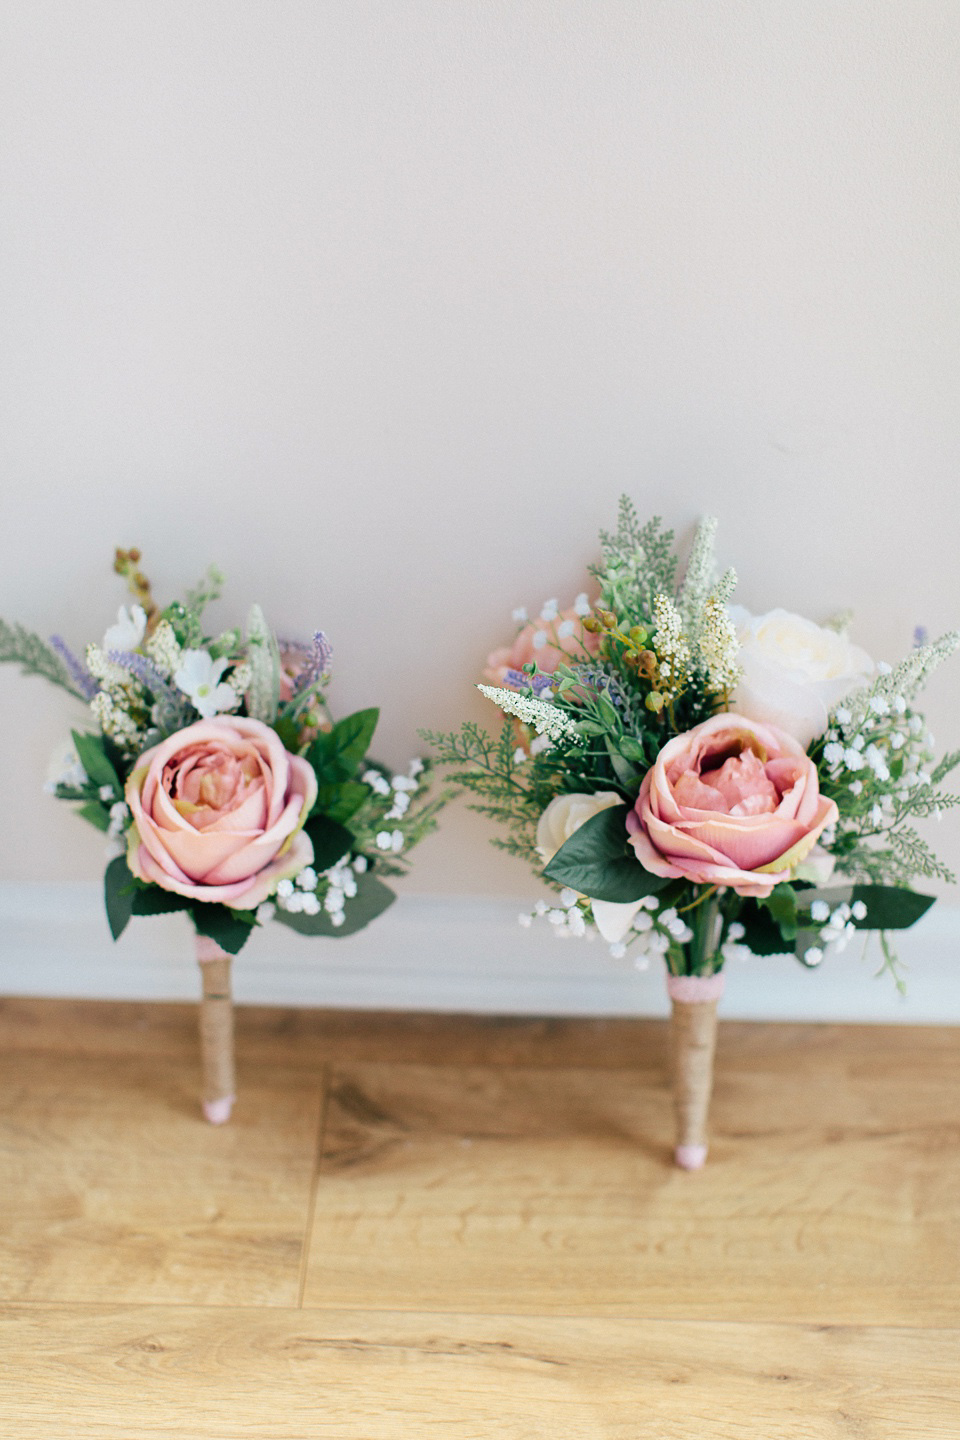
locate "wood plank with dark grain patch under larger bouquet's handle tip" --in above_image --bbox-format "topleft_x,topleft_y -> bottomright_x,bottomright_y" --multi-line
305,1059 -> 960,1325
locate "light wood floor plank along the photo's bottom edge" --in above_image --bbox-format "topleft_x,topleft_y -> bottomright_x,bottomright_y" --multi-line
0,1306 -> 960,1440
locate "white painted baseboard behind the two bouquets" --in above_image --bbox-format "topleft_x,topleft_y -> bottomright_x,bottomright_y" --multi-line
0,883 -> 960,1024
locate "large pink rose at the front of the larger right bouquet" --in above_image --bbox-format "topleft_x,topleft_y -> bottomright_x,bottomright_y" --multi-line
626,714 -> 838,897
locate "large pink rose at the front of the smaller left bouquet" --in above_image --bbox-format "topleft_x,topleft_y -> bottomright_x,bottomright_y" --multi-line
127,716 -> 317,910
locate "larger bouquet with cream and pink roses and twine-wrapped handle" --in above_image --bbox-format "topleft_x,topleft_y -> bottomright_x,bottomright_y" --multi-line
427,497 -> 960,1169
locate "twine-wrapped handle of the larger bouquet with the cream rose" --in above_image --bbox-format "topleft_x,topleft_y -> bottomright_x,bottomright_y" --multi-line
666,972 -> 724,1169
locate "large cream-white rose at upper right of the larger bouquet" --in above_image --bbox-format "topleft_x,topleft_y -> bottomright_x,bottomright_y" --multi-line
730,606 -> 875,747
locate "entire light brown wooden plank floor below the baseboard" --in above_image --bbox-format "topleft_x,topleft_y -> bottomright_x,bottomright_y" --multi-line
0,999 -> 960,1440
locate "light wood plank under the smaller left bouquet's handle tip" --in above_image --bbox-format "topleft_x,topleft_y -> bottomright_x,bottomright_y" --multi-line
0,1053 -> 321,1305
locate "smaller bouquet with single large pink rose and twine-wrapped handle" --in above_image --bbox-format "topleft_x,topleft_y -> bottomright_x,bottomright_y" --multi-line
0,550 -> 445,1123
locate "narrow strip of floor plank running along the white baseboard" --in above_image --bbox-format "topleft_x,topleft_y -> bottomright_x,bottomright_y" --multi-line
0,996 -> 960,1083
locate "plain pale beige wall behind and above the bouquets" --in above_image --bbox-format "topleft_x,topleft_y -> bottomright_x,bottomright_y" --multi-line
0,0 -> 960,896
